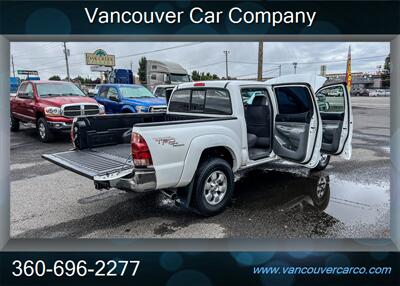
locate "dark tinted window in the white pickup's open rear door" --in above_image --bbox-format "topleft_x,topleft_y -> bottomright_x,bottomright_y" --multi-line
275,86 -> 312,114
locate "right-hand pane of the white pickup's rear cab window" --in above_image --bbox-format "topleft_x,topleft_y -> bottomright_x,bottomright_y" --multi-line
204,89 -> 232,115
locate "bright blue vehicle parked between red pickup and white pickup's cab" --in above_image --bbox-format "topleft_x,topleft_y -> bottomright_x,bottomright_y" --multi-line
94,84 -> 167,114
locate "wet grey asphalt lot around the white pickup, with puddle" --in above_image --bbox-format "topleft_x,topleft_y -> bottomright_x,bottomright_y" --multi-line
10,97 -> 390,238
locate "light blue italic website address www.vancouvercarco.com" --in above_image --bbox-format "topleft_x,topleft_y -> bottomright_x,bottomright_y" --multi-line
253,266 -> 392,275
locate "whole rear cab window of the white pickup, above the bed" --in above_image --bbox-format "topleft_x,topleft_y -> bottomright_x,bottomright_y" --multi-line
169,88 -> 232,115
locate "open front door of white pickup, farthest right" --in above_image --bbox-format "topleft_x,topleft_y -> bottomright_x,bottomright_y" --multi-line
316,83 -> 353,159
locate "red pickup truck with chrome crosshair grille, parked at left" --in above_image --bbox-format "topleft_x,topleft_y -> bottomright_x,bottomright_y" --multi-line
10,81 -> 104,142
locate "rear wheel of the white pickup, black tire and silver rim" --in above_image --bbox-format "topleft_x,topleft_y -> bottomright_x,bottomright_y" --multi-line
192,158 -> 234,216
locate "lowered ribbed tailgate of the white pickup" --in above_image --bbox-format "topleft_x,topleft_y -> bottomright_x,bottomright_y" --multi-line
42,144 -> 134,181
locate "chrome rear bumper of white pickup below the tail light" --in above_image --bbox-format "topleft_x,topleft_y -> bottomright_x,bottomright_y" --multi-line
94,169 -> 157,193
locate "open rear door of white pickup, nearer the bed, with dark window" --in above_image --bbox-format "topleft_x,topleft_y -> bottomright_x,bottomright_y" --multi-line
272,83 -> 322,168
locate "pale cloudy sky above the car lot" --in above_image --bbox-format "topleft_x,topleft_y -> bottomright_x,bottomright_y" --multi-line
10,42 -> 390,79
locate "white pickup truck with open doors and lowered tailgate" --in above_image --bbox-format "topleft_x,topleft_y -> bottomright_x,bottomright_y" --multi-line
43,76 -> 353,216
